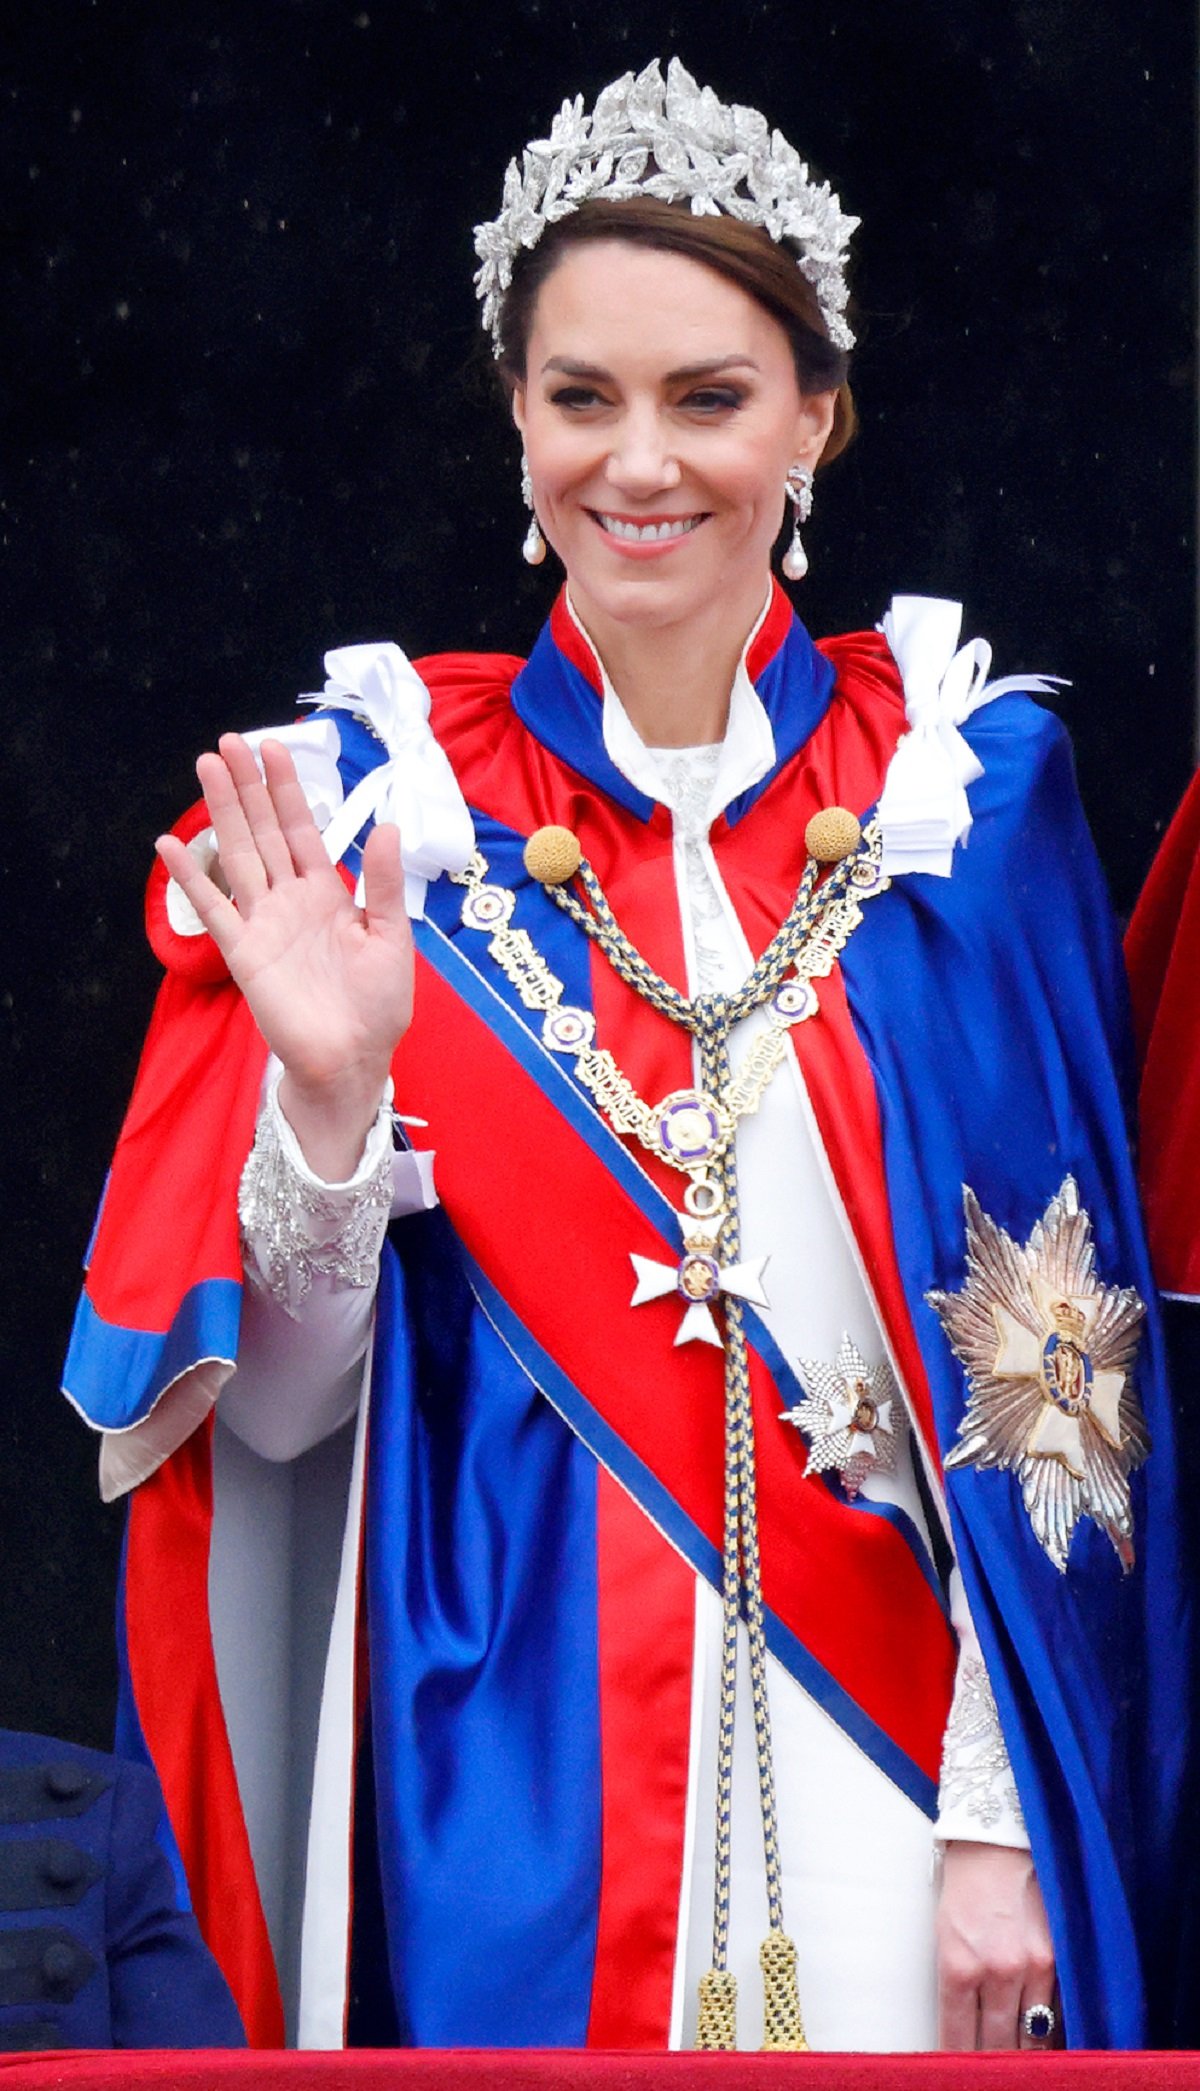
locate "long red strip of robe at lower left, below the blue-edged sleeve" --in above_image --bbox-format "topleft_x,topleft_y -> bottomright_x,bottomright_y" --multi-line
125,1422 -> 284,2047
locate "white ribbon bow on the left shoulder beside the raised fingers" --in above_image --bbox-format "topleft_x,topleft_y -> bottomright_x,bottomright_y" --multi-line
309,642 -> 475,920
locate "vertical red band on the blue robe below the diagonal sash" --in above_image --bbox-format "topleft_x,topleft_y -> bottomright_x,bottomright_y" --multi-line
587,1470 -> 696,2047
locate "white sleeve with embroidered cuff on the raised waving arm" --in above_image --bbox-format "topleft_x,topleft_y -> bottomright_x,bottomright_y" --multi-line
222,1066 -> 437,1460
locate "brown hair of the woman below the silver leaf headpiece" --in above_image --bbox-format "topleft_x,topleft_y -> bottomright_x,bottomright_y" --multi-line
500,197 -> 855,464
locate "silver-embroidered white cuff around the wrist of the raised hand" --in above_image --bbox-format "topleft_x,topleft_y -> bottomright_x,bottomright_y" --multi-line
238,1069 -> 393,1319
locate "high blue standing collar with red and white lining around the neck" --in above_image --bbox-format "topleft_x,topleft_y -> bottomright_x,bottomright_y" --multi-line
512,583 -> 834,824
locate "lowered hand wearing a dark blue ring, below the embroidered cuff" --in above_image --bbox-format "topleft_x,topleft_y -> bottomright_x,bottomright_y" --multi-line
937,1840 -> 1062,2049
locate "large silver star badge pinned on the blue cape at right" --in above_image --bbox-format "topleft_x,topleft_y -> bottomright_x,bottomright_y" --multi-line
928,1177 -> 1150,1572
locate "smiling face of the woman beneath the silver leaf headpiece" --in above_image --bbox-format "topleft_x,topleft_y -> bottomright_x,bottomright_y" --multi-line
512,240 -> 834,642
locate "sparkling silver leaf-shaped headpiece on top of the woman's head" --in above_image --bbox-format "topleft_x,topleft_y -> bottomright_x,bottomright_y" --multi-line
475,59 -> 859,355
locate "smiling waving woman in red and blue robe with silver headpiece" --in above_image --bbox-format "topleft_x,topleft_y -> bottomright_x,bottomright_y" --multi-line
67,53 -> 1183,2047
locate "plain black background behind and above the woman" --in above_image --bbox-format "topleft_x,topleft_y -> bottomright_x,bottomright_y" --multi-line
0,0 -> 1196,1742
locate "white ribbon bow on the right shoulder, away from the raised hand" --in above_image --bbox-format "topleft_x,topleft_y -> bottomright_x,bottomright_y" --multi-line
878,596 -> 1062,878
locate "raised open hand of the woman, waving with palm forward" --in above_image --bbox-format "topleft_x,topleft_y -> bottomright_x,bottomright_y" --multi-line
157,734 -> 412,1181
